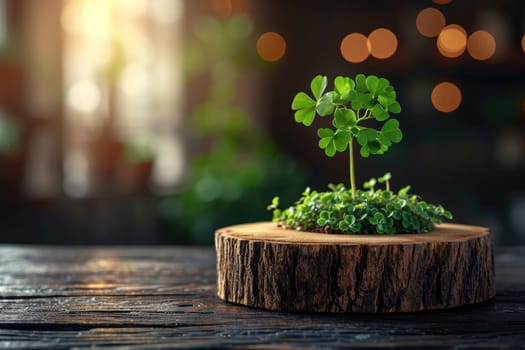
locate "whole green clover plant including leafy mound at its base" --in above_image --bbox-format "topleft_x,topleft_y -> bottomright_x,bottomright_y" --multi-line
268,74 -> 452,234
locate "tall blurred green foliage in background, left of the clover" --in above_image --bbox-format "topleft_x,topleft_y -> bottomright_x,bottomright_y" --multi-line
161,14 -> 306,244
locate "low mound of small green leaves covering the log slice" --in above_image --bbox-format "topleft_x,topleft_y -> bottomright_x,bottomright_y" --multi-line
268,173 -> 452,234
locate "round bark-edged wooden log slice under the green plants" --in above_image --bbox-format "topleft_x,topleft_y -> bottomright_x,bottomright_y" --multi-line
215,222 -> 495,313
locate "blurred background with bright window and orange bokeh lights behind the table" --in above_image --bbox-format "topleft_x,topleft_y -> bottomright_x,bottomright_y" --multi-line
0,0 -> 525,245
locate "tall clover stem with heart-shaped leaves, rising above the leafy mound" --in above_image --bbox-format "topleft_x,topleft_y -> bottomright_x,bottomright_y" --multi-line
292,74 -> 403,198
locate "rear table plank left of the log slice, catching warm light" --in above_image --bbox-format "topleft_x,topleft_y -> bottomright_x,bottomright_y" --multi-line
0,247 -> 215,298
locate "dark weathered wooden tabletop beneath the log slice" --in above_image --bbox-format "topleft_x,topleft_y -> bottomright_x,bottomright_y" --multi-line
0,246 -> 525,349
